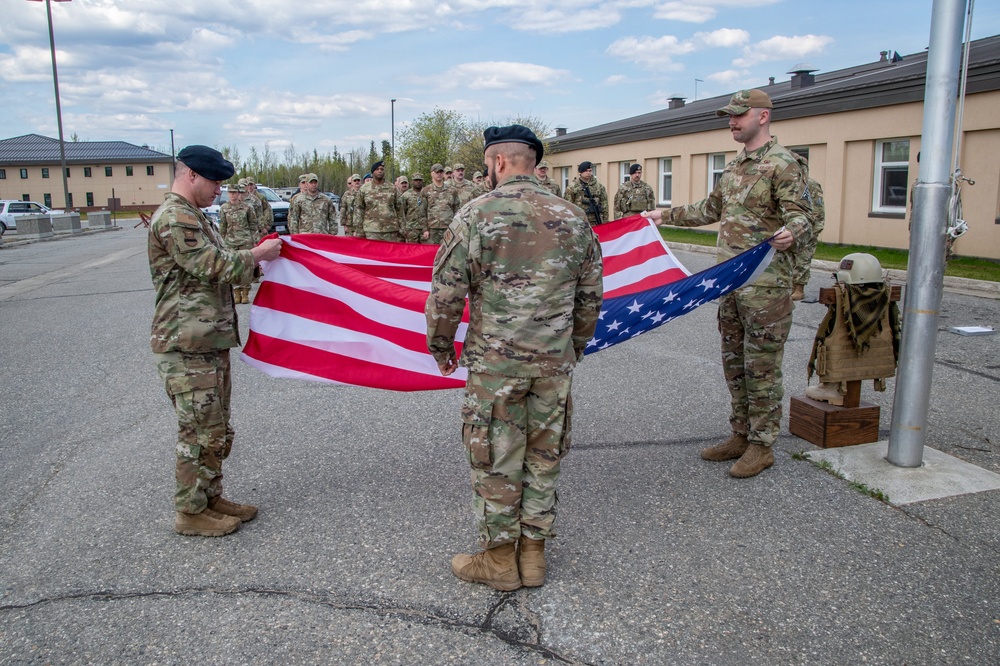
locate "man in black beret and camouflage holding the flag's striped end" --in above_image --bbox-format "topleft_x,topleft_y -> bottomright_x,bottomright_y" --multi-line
148,146 -> 281,536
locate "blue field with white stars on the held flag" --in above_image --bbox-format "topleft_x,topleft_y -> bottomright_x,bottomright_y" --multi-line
585,241 -> 774,354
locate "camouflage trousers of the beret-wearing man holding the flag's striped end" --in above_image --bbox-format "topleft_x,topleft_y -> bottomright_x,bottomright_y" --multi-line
154,349 -> 234,513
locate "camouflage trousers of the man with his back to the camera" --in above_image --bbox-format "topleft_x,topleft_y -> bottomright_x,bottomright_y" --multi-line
462,372 -> 573,548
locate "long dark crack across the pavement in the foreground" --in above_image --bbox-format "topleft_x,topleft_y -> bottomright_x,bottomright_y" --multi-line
0,587 -> 591,666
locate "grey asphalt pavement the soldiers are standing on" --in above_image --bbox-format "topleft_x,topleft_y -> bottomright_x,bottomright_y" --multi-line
0,224 -> 1000,666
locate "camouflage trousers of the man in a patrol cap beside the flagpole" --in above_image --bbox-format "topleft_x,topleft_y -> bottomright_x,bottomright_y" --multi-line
719,287 -> 792,446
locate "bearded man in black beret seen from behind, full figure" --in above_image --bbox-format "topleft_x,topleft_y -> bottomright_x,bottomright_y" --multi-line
426,125 -> 603,590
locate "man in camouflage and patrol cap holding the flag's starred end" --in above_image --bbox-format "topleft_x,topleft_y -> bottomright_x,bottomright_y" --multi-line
647,90 -> 811,478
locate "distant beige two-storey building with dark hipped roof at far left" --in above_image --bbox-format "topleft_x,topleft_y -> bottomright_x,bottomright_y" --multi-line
0,134 -> 173,210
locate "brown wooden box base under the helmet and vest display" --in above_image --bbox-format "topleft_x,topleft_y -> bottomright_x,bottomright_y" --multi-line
788,395 -> 880,449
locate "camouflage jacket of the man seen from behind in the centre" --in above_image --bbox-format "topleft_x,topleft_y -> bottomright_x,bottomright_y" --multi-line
425,176 -> 604,377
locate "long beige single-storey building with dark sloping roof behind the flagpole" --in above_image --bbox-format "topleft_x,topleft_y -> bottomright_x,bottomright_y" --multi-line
546,36 -> 1000,259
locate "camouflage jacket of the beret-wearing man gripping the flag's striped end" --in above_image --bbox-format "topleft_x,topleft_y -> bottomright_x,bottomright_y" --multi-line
148,192 -> 254,354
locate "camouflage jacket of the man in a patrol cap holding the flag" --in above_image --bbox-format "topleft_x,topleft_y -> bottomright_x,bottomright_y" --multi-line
664,137 -> 812,289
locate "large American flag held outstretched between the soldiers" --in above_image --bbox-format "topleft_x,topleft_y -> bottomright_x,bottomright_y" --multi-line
241,215 -> 770,391
